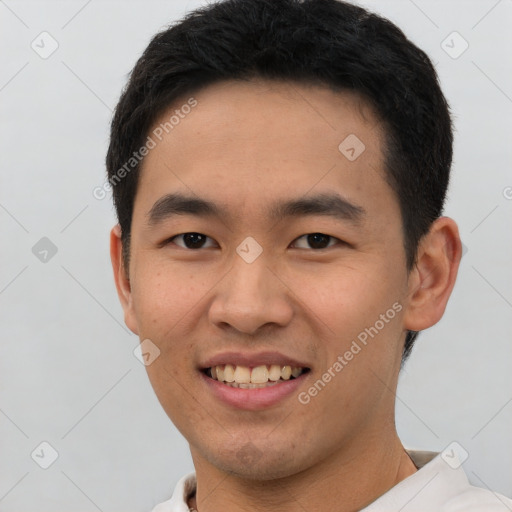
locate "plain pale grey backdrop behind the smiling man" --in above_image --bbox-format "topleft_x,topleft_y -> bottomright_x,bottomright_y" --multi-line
0,0 -> 512,512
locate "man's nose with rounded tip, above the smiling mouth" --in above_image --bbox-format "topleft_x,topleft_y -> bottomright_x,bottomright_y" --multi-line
209,256 -> 294,335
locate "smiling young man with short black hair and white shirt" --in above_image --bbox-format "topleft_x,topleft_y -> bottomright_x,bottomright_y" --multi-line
107,0 -> 512,512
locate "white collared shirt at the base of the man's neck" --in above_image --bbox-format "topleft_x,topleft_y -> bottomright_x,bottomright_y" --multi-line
152,450 -> 512,512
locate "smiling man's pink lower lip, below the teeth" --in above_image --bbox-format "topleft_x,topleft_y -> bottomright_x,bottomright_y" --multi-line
199,372 -> 310,411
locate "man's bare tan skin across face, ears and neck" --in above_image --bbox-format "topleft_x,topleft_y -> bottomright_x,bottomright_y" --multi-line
111,80 -> 461,512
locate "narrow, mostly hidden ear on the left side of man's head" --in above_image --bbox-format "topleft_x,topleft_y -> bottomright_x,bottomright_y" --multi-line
110,224 -> 139,335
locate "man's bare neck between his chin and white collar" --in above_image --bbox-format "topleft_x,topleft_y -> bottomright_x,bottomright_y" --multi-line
189,433 -> 416,512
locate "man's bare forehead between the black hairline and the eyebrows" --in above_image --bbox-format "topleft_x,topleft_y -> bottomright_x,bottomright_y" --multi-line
136,80 -> 392,226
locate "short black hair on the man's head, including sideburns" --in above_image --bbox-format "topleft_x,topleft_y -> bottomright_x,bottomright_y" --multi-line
106,0 -> 453,361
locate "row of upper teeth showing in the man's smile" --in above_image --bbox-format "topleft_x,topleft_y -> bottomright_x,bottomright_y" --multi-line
209,364 -> 304,384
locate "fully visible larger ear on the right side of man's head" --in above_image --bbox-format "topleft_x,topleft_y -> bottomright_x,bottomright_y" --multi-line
404,217 -> 462,331
